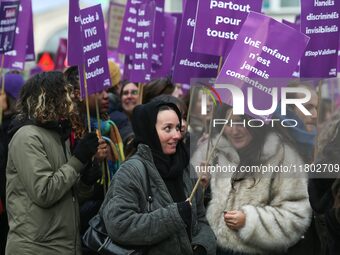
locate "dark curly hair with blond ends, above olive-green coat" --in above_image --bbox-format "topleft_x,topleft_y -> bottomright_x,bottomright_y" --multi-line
17,71 -> 73,123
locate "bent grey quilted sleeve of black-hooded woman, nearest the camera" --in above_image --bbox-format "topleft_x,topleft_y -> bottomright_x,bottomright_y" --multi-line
101,164 -> 185,245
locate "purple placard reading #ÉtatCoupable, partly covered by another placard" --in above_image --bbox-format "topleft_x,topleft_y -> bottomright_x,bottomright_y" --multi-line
172,0 -> 219,83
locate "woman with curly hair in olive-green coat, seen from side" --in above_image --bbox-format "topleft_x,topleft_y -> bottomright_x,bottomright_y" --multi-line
6,72 -> 98,255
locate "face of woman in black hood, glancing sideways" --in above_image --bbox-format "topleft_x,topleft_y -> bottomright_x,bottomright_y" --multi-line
156,110 -> 181,155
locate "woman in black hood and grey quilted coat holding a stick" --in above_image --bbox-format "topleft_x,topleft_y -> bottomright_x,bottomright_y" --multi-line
100,101 -> 216,255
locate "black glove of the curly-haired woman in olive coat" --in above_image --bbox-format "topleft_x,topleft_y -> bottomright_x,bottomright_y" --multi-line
74,132 -> 99,164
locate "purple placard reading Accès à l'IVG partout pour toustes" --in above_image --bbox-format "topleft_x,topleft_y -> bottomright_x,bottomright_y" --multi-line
79,4 -> 111,95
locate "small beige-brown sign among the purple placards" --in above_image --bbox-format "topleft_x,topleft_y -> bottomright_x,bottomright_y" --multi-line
107,0 -> 125,49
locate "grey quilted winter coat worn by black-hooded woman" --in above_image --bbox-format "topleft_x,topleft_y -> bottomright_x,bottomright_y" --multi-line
100,144 -> 216,255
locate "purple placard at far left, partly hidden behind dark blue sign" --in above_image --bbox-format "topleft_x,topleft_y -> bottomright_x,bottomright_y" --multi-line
4,0 -> 32,70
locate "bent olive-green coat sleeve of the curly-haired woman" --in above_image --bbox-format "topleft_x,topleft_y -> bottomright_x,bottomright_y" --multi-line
10,128 -> 83,208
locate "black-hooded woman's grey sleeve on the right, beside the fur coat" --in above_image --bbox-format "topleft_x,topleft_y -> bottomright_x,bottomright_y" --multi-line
192,179 -> 216,255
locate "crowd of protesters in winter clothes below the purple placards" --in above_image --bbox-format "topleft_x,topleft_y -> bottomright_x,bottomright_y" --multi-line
0,64 -> 340,255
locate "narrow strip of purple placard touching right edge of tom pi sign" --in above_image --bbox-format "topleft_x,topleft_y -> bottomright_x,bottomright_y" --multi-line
151,0 -> 165,65
